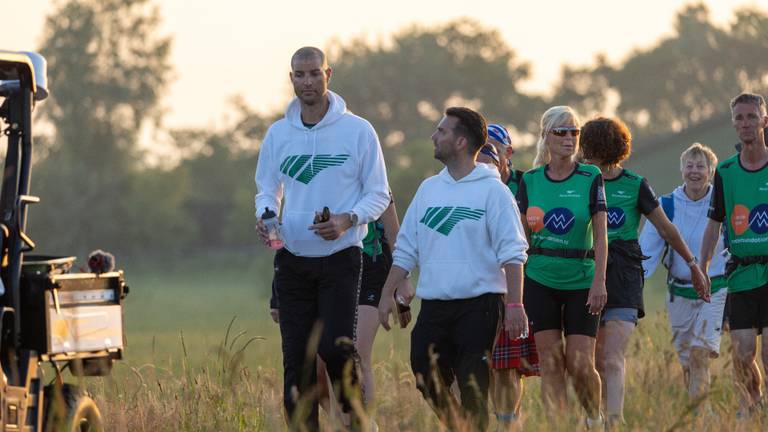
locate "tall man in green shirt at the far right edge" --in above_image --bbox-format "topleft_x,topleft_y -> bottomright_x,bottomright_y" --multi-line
701,93 -> 768,413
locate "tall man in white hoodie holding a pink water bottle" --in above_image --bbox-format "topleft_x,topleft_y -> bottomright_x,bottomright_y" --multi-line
256,47 -> 390,430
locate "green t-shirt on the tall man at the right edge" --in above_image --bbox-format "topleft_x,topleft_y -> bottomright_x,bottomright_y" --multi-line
709,153 -> 768,292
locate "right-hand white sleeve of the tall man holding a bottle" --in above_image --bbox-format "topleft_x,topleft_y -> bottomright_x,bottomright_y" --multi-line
352,124 -> 390,225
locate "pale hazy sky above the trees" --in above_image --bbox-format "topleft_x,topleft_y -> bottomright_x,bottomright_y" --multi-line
6,0 -> 766,127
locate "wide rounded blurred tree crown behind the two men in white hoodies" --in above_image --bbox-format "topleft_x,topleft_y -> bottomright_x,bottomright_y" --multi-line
328,18 -> 541,148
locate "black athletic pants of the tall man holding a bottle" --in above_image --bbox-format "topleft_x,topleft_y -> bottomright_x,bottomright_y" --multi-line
275,247 -> 362,430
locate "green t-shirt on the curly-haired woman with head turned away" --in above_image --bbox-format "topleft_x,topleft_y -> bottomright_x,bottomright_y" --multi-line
603,169 -> 659,243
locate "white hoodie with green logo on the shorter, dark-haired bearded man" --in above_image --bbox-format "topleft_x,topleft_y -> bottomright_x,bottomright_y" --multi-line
393,164 -> 528,300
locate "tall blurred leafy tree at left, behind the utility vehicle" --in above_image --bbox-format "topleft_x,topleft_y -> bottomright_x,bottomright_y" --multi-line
30,0 -> 177,253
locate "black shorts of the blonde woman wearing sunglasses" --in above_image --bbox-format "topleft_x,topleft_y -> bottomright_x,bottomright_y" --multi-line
523,276 -> 600,337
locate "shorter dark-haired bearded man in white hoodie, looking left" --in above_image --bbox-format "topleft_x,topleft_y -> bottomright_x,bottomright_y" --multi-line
379,107 -> 528,430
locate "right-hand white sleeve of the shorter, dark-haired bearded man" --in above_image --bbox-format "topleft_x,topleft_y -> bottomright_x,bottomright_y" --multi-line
485,183 -> 528,267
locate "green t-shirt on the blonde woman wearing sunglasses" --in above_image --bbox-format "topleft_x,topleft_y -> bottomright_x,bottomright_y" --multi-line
517,163 -> 605,290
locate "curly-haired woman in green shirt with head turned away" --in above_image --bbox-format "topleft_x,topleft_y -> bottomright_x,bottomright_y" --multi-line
581,117 -> 706,427
